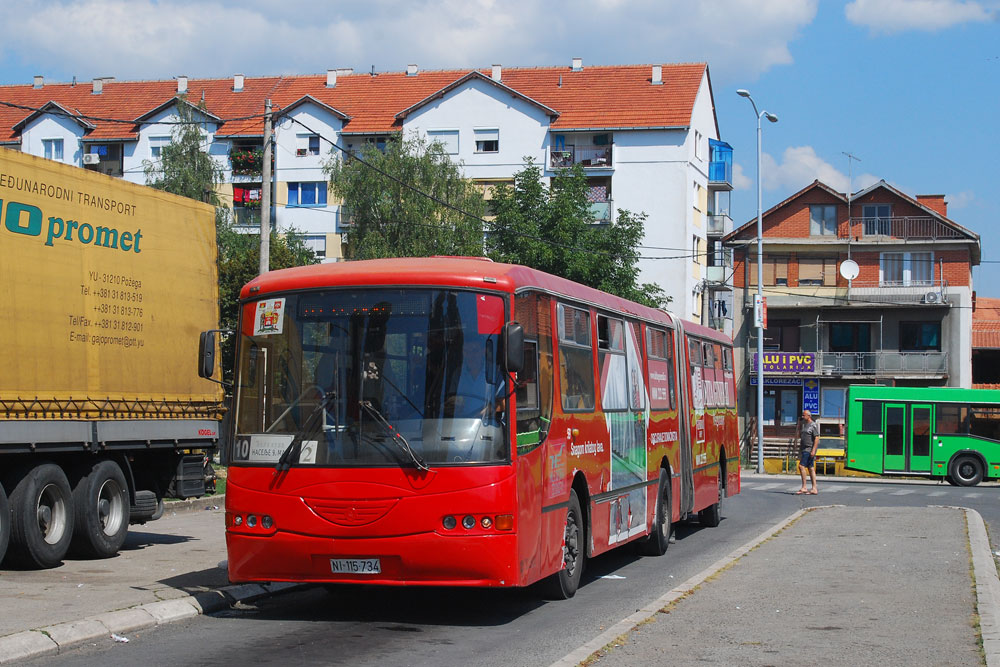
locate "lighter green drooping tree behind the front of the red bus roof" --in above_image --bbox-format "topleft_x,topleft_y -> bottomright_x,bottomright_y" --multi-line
325,136 -> 485,259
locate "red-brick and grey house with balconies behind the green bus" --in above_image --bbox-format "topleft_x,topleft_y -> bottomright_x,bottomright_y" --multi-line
723,181 -> 981,452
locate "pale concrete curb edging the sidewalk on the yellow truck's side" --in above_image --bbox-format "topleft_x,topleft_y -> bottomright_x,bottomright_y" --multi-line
0,583 -> 310,665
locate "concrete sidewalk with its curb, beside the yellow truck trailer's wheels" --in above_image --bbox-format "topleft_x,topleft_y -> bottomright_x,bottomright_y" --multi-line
0,496 -> 306,664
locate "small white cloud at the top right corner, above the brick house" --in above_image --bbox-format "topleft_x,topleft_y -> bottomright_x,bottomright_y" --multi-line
844,0 -> 996,33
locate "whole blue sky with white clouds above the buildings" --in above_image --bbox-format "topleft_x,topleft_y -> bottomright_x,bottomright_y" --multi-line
0,0 -> 1000,290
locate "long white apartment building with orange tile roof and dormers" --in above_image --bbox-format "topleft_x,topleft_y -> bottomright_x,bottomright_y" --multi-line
0,58 -> 732,330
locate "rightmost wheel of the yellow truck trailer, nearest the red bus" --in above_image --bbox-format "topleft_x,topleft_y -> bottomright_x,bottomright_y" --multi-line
71,459 -> 129,558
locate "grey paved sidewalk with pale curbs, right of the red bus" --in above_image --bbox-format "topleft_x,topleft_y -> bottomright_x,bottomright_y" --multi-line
555,506 -> 1000,667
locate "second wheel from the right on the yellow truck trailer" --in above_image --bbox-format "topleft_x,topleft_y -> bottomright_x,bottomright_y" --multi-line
10,463 -> 73,568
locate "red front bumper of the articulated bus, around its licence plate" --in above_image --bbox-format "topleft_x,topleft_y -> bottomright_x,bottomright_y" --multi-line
226,528 -> 517,587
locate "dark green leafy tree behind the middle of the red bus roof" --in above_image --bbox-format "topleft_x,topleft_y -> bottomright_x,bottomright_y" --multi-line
488,159 -> 669,307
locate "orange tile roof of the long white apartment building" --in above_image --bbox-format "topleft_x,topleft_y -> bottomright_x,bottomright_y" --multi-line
0,63 -> 707,143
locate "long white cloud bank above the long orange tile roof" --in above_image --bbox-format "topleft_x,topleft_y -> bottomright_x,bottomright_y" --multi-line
0,0 -> 818,86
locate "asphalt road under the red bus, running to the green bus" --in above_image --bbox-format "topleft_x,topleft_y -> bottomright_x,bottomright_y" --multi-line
25,477 -> 1000,667
